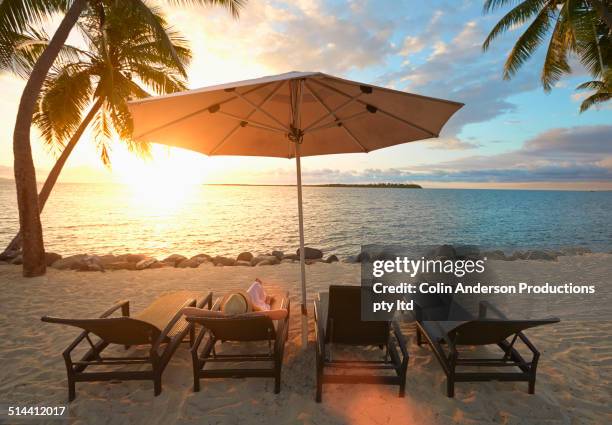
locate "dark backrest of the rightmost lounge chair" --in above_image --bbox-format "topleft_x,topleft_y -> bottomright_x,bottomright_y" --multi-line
448,318 -> 559,345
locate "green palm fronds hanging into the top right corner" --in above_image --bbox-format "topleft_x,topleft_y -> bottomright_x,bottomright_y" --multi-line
483,0 -> 612,105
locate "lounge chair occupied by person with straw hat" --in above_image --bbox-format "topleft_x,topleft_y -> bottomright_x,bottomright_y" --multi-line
186,294 -> 290,394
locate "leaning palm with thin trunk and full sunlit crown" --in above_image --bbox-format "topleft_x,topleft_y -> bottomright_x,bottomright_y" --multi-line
0,4 -> 191,253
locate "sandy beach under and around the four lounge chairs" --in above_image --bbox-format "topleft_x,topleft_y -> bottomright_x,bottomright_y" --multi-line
0,254 -> 612,424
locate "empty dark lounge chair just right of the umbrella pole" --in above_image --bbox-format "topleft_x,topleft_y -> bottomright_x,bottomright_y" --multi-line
314,285 -> 408,402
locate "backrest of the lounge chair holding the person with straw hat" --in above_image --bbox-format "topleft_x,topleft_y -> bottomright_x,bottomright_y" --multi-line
187,315 -> 276,341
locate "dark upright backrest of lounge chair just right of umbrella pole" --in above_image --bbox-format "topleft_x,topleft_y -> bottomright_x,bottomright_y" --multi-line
325,285 -> 390,345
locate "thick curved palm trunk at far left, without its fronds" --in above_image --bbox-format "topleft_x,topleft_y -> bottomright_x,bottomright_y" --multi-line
13,0 -> 87,277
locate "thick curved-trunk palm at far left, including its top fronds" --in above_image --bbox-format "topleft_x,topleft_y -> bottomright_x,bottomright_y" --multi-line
0,0 -> 245,277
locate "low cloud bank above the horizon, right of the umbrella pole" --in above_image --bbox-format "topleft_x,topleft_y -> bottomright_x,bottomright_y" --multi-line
262,125 -> 612,186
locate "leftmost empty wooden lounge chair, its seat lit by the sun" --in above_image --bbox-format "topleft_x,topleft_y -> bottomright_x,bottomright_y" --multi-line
41,291 -> 212,401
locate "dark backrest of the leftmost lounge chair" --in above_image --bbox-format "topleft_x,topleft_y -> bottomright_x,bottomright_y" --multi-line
41,316 -> 161,345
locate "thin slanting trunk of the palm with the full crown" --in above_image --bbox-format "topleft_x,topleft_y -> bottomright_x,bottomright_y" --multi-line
0,99 -> 103,258
